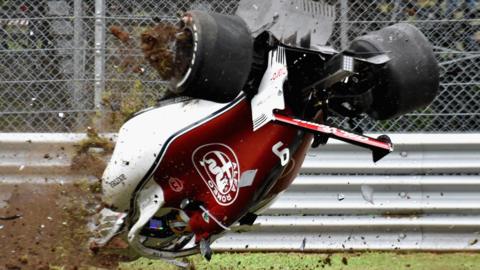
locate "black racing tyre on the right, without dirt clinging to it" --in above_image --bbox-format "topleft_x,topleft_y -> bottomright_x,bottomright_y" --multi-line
349,23 -> 439,120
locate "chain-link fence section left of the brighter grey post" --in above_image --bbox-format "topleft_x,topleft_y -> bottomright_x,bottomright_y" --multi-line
0,0 -> 94,132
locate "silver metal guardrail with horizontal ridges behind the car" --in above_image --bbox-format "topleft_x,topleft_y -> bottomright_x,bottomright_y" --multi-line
0,134 -> 480,251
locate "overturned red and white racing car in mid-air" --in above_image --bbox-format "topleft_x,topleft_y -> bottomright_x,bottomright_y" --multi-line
93,0 -> 439,262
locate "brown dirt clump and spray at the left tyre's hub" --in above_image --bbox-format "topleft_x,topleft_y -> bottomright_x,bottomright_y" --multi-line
102,18 -> 193,131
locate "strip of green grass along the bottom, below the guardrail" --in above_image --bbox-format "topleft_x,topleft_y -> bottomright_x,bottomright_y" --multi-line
119,252 -> 480,270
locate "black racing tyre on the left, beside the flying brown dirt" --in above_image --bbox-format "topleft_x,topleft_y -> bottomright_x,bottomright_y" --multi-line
171,11 -> 253,103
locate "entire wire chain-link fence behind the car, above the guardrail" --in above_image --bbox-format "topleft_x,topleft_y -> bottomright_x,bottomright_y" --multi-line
0,0 -> 480,132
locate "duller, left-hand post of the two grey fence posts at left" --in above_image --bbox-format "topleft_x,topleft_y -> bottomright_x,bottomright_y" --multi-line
73,0 -> 87,128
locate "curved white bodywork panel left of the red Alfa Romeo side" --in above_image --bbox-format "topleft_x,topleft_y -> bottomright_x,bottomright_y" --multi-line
102,99 -> 228,211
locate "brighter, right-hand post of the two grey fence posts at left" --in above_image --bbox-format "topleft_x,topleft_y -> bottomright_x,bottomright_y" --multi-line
94,0 -> 106,111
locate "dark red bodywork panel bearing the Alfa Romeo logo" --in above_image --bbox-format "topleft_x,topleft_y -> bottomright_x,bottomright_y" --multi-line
154,99 -> 311,240
